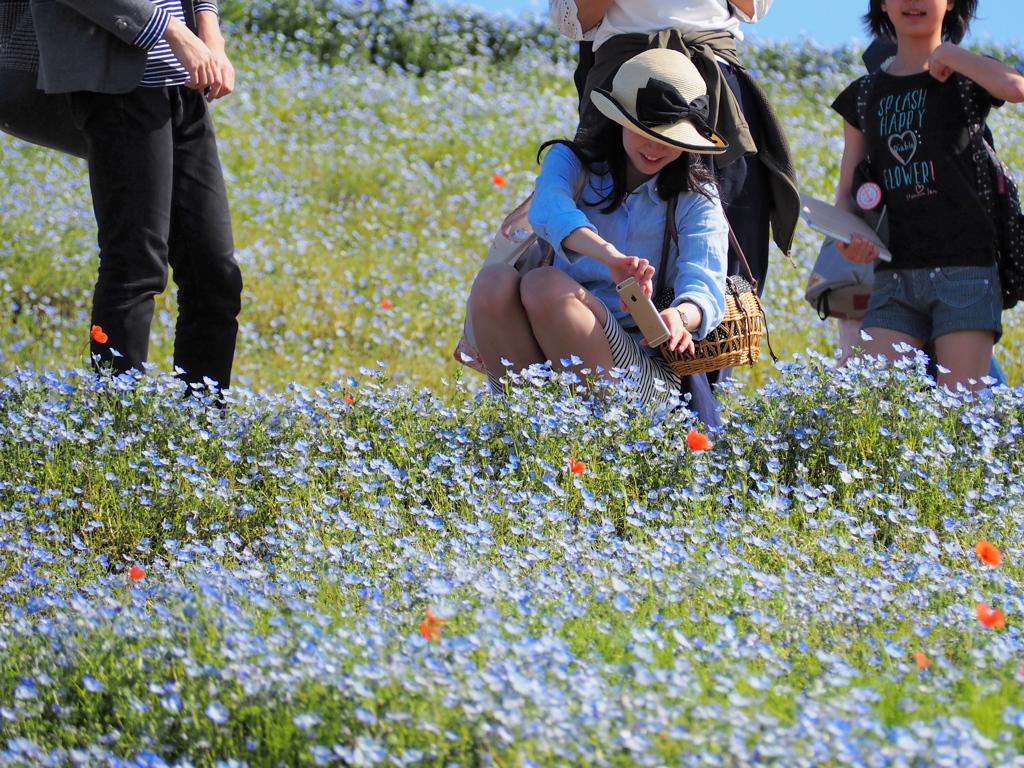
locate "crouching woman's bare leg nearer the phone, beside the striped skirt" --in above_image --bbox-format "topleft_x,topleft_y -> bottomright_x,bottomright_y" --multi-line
520,267 -> 612,378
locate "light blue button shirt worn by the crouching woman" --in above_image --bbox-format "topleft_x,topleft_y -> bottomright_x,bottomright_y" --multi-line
529,144 -> 729,354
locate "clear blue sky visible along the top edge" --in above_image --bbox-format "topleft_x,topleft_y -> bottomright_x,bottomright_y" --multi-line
460,0 -> 1024,46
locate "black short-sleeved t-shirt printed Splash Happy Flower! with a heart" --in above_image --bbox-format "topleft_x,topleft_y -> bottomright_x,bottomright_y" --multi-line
833,72 -> 1001,269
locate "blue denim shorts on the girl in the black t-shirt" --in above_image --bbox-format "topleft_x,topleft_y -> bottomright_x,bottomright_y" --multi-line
861,265 -> 1002,341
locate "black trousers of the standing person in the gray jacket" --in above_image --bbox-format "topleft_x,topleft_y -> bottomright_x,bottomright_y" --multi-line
69,86 -> 242,389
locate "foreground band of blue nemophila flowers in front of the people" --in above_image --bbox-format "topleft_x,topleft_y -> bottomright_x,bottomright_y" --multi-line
0,356 -> 1024,766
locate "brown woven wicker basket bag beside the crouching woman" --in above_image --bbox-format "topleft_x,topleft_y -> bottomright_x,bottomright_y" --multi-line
662,274 -> 765,376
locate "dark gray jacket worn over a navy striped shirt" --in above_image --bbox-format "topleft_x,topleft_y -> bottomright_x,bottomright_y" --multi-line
31,0 -> 211,93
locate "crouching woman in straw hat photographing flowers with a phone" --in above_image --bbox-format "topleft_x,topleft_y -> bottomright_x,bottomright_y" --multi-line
469,49 -> 729,425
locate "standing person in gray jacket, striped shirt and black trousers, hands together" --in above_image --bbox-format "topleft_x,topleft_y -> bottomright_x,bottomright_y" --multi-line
32,0 -> 242,389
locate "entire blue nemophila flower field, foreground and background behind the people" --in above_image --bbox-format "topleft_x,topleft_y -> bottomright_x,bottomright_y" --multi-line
0,3 -> 1024,768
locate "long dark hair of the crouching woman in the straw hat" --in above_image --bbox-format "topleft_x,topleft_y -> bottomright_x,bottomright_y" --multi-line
537,120 -> 717,213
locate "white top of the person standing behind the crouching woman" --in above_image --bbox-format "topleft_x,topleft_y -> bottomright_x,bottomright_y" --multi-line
548,0 -> 772,50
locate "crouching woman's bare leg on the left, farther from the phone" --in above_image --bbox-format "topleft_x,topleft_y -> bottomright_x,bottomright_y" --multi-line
469,264 -> 547,378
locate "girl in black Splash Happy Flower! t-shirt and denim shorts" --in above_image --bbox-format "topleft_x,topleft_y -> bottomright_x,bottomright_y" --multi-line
833,0 -> 1024,390
